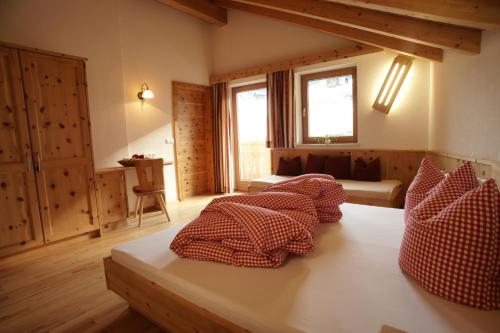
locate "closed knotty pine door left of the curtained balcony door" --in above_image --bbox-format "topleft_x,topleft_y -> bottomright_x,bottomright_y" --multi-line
172,82 -> 214,200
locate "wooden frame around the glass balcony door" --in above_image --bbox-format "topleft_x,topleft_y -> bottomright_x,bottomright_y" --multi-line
231,82 -> 267,192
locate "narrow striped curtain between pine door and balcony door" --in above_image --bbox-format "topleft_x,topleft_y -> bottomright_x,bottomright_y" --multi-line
212,82 -> 232,193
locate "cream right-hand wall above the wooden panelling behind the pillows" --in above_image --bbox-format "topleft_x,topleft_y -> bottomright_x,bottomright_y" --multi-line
429,31 -> 500,161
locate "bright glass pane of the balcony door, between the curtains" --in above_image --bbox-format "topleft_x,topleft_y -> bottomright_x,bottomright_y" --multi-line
236,88 -> 271,180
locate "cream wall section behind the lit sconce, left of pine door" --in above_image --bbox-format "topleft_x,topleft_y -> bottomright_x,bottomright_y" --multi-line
119,0 -> 213,201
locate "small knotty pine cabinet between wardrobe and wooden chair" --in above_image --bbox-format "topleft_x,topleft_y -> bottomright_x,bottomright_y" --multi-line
96,168 -> 128,227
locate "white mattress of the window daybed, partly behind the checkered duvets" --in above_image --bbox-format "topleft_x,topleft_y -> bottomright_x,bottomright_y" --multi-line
250,175 -> 402,200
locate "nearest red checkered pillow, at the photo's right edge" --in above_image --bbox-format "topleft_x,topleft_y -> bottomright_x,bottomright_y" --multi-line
399,180 -> 500,310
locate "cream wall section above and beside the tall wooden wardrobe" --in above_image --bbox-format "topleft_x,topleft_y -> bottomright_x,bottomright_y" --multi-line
0,0 -> 128,167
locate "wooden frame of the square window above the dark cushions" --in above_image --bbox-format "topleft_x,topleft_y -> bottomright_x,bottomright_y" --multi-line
300,66 -> 358,144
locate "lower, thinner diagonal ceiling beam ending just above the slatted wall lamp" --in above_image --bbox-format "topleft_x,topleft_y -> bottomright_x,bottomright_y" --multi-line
214,0 -> 443,62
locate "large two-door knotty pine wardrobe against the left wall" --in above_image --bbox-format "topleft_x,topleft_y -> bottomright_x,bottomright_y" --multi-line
0,44 -> 99,256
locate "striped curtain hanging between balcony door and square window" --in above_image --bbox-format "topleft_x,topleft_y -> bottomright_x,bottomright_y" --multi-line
266,70 -> 295,148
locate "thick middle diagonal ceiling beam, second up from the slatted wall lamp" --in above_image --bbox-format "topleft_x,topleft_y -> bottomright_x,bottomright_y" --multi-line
236,0 -> 481,53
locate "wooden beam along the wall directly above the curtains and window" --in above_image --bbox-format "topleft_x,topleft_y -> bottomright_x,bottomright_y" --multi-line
210,44 -> 383,84
